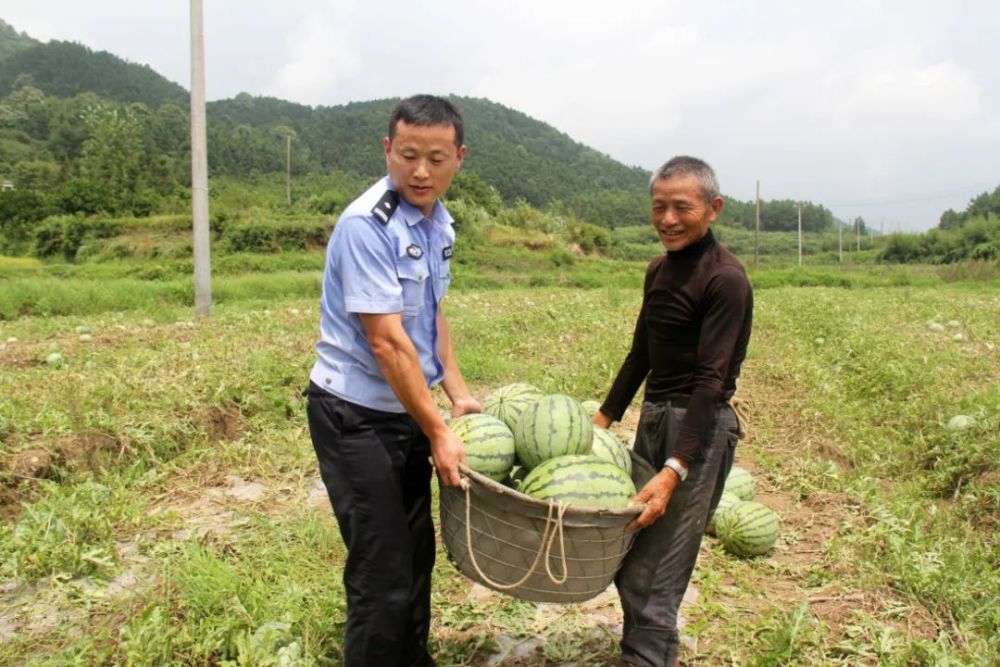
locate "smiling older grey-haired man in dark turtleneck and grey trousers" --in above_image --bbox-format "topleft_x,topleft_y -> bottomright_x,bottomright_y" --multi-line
593,156 -> 753,667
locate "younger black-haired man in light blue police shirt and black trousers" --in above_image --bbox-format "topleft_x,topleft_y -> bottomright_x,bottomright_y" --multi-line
307,95 -> 481,667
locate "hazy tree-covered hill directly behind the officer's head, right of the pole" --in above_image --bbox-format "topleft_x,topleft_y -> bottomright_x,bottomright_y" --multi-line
209,95 -> 648,206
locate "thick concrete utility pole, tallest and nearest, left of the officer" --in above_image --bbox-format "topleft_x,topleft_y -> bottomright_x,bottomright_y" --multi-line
191,0 -> 212,317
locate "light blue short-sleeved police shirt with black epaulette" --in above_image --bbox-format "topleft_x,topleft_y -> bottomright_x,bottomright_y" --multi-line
309,176 -> 455,413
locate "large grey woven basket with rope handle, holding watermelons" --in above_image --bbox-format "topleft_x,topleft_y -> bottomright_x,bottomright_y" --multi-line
440,465 -> 642,603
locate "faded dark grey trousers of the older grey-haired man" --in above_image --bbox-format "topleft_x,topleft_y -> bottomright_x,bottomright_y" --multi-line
615,400 -> 737,667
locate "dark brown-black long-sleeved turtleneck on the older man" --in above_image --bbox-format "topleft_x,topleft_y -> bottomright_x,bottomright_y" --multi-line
601,229 -> 753,464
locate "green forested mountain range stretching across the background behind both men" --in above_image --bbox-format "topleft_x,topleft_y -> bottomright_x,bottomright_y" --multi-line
0,18 -> 848,230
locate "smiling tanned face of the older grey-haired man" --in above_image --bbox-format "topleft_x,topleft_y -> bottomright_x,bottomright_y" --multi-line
650,174 -> 722,250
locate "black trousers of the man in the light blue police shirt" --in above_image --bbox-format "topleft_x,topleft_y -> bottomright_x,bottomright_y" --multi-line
307,383 -> 434,667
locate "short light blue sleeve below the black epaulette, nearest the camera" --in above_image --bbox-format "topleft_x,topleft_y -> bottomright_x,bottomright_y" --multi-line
330,216 -> 403,314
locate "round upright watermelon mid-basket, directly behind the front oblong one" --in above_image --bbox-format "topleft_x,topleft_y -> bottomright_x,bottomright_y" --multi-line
514,394 -> 594,469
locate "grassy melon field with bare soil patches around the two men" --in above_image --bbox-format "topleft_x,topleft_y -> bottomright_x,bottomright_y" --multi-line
0,264 -> 1000,667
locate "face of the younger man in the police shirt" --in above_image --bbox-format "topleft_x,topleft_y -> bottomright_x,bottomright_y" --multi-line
383,121 -> 466,215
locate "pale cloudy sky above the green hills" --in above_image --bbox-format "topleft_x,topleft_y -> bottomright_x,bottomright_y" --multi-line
0,0 -> 1000,233
